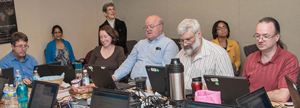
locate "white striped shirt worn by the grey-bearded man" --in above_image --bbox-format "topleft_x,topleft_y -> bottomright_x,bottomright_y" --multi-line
176,38 -> 234,89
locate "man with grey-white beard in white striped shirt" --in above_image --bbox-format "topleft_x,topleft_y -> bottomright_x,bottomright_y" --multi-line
176,19 -> 234,89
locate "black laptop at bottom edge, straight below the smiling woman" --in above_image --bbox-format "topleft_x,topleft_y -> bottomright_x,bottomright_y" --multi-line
90,88 -> 131,108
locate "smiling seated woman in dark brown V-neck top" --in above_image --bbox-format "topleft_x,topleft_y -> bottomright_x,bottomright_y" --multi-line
88,25 -> 126,75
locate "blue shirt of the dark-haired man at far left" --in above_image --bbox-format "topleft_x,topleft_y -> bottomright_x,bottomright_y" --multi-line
0,51 -> 39,80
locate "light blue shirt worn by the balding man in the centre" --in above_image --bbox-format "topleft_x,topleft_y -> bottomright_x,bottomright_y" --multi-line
113,33 -> 178,86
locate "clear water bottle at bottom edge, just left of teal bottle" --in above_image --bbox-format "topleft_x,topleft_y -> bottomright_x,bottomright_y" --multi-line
8,84 -> 18,108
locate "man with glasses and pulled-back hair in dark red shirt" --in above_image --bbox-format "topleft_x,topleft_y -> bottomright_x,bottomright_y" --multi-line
243,17 -> 299,102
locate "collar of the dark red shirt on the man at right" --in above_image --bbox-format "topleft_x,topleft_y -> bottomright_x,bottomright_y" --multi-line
255,44 -> 284,65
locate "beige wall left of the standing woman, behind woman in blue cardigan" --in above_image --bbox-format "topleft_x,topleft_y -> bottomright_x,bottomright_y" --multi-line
0,0 -> 112,64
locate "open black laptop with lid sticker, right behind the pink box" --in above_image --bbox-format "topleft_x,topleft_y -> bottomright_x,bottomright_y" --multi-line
204,75 -> 250,106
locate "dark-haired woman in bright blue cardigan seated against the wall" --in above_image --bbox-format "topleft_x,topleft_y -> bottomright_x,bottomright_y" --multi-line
45,25 -> 75,65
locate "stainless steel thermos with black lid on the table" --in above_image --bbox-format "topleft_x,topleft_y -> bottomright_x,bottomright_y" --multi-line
168,58 -> 185,100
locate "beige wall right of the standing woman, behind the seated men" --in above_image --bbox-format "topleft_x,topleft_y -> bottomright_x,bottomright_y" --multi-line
113,0 -> 300,74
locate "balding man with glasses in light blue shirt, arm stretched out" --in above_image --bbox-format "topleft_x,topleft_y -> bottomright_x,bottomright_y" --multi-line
112,15 -> 178,87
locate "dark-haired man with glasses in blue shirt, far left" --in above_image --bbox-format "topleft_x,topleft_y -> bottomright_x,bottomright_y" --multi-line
0,32 -> 38,85
